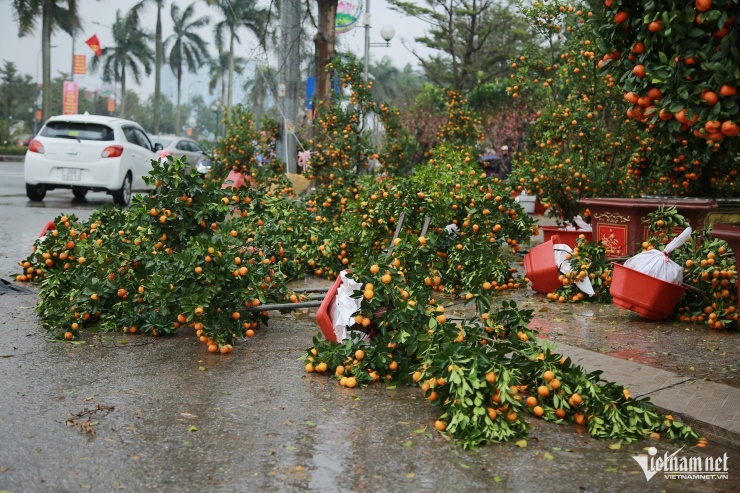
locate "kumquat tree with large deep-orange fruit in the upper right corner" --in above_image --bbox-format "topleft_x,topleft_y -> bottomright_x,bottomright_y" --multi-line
592,0 -> 740,197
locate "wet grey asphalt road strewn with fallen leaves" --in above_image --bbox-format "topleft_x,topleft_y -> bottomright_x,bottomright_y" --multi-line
0,163 -> 740,493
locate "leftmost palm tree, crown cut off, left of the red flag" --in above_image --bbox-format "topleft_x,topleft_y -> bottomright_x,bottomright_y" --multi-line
12,0 -> 80,118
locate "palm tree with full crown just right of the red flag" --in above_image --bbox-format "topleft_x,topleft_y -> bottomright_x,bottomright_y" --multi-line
90,10 -> 154,117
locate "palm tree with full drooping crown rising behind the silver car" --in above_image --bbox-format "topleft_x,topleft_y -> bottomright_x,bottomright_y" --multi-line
164,3 -> 210,135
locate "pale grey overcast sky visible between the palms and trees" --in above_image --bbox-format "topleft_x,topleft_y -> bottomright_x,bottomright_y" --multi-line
0,0 -> 426,101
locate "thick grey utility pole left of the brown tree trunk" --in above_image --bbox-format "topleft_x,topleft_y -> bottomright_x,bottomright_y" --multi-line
278,0 -> 302,173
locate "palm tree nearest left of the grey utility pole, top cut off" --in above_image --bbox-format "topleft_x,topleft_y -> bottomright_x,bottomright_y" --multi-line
206,0 -> 269,113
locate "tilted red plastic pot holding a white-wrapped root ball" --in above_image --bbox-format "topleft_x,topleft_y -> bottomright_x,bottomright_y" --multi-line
609,264 -> 686,320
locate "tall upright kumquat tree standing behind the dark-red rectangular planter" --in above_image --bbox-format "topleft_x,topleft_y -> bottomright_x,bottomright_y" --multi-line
508,0 -> 642,222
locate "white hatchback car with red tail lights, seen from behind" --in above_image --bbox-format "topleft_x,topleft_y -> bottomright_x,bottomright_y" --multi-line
24,114 -> 161,207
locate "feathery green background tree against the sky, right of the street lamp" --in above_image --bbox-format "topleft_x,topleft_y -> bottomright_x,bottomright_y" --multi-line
388,0 -> 530,94
